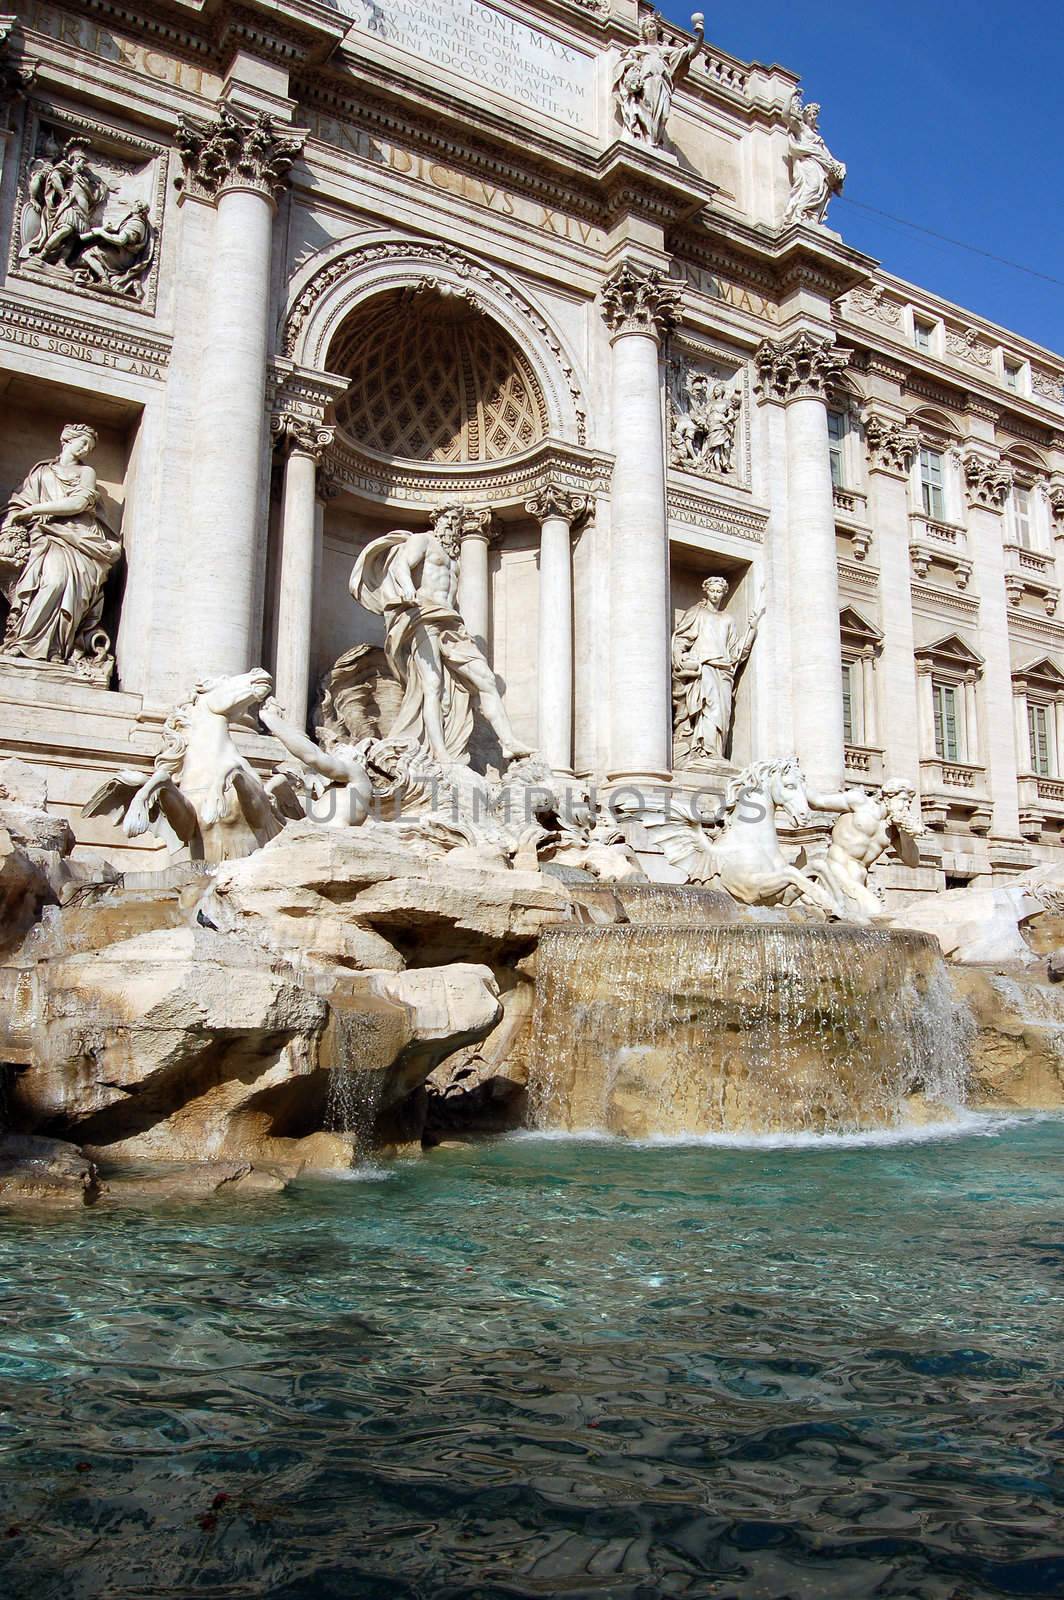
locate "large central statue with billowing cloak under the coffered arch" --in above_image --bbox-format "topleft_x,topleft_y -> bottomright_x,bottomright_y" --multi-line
350,509 -> 531,765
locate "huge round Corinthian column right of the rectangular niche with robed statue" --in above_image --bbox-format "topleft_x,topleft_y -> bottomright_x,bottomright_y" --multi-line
755,333 -> 851,792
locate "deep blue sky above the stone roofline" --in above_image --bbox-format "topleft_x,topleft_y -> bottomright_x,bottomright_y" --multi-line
661,0 -> 1064,354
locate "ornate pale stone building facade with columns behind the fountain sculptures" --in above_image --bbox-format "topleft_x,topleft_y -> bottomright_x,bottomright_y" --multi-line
0,0 -> 1064,896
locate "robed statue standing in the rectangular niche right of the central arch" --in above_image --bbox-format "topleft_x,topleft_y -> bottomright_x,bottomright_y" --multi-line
672,578 -> 765,766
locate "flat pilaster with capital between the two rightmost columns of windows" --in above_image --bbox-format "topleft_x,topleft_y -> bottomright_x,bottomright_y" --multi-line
960,443 -> 1019,840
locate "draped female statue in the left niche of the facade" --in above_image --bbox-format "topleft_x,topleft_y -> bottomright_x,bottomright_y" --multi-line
0,422 -> 122,664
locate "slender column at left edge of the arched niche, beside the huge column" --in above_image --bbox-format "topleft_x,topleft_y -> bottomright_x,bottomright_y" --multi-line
274,416 -> 333,728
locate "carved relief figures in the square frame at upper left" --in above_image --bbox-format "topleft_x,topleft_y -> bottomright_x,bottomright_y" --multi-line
19,138 -> 155,299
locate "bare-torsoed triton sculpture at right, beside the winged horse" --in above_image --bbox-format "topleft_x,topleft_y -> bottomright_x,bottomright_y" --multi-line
806,778 -> 920,922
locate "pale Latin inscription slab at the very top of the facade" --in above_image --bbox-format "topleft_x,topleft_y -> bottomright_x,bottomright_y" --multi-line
338,0 -> 595,130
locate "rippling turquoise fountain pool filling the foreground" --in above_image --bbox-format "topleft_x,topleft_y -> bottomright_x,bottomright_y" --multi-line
0,1115 -> 1064,1600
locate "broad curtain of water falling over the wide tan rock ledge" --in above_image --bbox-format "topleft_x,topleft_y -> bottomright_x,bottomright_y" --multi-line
530,915 -> 966,1138
